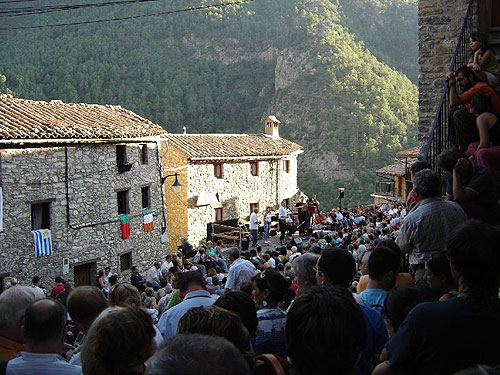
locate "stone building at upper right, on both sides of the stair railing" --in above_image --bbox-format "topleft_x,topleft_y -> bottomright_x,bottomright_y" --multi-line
418,0 -> 500,141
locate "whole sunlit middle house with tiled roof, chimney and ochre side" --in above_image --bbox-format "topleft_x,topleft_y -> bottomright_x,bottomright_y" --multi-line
163,116 -> 303,249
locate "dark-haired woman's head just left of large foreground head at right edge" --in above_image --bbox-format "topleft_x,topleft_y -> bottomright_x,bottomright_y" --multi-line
424,254 -> 458,301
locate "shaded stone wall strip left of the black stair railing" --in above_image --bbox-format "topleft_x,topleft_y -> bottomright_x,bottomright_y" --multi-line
418,0 -> 477,142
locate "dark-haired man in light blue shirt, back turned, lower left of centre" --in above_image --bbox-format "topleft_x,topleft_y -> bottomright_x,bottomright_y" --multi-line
158,271 -> 215,339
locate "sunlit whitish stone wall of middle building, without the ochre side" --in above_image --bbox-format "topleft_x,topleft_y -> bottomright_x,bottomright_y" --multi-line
187,156 -> 298,245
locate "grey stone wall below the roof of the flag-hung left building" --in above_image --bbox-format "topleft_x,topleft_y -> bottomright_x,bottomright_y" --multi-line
0,142 -> 168,286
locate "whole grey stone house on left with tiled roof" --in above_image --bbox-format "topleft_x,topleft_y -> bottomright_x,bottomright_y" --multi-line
0,95 -> 168,286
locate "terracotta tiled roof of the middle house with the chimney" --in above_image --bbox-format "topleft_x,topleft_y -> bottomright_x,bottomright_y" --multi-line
166,134 -> 302,159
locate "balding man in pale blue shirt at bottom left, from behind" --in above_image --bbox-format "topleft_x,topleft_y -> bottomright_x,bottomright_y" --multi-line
6,299 -> 82,375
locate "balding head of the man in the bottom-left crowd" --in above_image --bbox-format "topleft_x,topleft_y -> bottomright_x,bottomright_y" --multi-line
23,299 -> 66,345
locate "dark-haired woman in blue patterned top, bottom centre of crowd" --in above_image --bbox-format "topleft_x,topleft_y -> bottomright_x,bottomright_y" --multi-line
252,269 -> 288,358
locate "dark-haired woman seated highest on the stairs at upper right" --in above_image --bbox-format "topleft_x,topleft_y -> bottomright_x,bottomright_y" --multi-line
467,32 -> 500,88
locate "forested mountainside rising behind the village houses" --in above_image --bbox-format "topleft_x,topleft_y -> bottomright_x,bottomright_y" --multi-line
0,0 -> 417,205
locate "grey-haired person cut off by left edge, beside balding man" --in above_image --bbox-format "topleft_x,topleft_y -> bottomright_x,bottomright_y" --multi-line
0,286 -> 38,361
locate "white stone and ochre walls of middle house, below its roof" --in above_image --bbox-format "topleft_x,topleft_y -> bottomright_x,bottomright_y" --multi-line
163,147 -> 299,250
